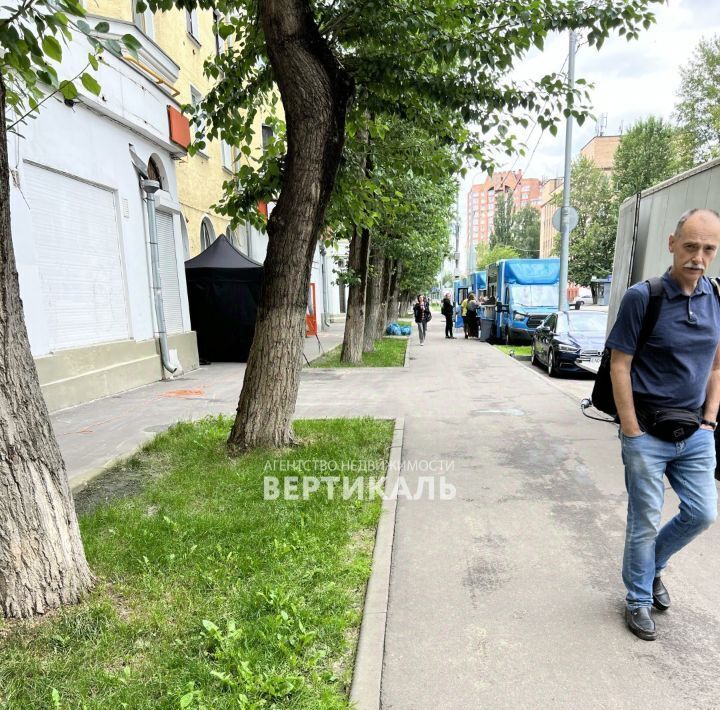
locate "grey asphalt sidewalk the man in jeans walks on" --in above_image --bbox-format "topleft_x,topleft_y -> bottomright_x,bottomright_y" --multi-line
53,319 -> 720,710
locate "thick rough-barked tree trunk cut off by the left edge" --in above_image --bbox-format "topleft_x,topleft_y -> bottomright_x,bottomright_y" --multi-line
0,74 -> 93,618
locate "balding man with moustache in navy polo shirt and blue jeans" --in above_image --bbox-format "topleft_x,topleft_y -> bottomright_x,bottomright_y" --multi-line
607,209 -> 720,641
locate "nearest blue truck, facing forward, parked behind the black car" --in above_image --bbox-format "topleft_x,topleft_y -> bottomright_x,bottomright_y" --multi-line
480,259 -> 560,344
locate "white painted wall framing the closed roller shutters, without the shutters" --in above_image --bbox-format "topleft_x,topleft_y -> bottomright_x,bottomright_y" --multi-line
9,30 -> 190,356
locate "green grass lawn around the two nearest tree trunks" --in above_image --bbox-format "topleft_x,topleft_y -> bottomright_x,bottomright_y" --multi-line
0,418 -> 393,710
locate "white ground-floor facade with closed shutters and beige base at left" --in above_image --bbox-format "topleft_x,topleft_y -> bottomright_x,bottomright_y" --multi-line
9,18 -> 198,411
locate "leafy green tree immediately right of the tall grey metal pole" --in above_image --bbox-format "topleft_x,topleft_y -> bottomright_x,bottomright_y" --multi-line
555,155 -> 618,286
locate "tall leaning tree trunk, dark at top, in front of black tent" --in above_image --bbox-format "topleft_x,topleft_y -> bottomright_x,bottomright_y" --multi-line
228,0 -> 353,451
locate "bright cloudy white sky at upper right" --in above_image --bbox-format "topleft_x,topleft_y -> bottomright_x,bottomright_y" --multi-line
460,0 -> 720,210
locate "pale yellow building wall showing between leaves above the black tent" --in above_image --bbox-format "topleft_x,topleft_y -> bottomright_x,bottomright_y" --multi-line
93,0 -> 264,261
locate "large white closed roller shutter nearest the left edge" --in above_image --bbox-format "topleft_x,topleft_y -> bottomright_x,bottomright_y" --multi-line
25,163 -> 130,354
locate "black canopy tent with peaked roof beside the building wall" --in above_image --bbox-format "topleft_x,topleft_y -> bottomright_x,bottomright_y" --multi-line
185,235 -> 263,362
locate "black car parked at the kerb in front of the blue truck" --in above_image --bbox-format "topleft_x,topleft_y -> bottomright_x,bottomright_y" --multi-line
532,311 -> 607,377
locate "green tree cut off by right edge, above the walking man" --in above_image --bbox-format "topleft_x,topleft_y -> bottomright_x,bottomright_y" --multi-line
675,36 -> 720,165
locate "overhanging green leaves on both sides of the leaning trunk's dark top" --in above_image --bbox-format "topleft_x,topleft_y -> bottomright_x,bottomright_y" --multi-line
143,0 -> 660,234
